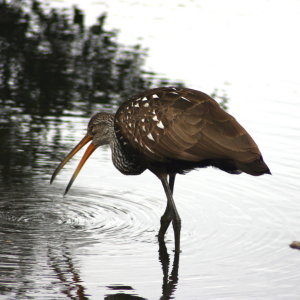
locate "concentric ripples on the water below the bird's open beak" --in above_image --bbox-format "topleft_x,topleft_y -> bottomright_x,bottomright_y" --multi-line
0,185 -> 160,248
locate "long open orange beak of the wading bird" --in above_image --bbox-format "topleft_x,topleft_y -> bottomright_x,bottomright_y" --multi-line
50,135 -> 96,195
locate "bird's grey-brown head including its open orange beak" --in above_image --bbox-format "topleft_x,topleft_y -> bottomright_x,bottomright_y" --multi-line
50,112 -> 114,194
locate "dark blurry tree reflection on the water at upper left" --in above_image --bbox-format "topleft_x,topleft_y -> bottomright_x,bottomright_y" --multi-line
0,0 -> 157,115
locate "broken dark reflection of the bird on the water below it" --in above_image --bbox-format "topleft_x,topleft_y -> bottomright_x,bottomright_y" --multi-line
48,241 -> 180,300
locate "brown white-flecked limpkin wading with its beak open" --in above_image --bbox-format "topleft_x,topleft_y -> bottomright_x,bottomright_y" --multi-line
51,87 -> 271,251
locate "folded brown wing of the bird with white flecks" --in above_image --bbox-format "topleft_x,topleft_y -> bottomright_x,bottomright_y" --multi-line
115,88 -> 260,162
